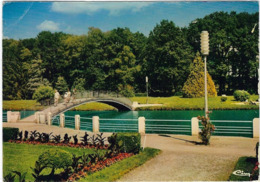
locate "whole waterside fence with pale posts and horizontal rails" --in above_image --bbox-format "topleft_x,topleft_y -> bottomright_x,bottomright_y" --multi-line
47,114 -> 259,137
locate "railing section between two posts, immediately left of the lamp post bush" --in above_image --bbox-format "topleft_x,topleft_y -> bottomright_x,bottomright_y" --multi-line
145,119 -> 191,135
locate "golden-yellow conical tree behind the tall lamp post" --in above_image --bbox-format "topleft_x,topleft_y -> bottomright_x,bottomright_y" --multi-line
182,53 -> 217,98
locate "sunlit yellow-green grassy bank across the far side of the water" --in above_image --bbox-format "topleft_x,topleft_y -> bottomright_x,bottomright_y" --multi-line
3,95 -> 259,111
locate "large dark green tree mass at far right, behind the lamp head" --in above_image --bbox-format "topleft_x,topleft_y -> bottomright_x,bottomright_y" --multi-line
186,12 -> 259,94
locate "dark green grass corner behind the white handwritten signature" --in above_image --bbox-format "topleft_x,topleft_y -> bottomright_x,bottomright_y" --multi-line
229,157 -> 256,181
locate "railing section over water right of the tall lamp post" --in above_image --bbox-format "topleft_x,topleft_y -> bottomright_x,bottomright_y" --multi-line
199,120 -> 253,137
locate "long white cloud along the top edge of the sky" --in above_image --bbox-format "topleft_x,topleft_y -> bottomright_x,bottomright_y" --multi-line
51,2 -> 153,15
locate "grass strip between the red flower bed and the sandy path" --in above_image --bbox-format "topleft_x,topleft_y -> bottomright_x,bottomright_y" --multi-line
79,147 -> 161,182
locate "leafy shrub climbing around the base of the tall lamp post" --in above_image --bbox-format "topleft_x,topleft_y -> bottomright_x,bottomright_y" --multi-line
198,116 -> 215,145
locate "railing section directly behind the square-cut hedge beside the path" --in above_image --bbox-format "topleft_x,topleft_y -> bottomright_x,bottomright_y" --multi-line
99,118 -> 138,132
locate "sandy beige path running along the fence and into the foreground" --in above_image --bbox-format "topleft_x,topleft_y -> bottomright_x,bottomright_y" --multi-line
3,123 -> 259,181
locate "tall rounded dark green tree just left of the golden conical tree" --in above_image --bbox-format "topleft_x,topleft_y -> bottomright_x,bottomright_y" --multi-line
145,20 -> 193,96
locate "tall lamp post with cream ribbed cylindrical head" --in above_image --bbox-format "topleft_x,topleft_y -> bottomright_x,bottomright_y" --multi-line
200,31 -> 209,117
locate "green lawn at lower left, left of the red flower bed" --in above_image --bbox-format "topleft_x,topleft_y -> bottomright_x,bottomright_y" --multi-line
3,142 -> 102,181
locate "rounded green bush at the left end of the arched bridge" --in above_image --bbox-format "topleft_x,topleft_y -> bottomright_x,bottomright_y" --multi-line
33,85 -> 54,105
